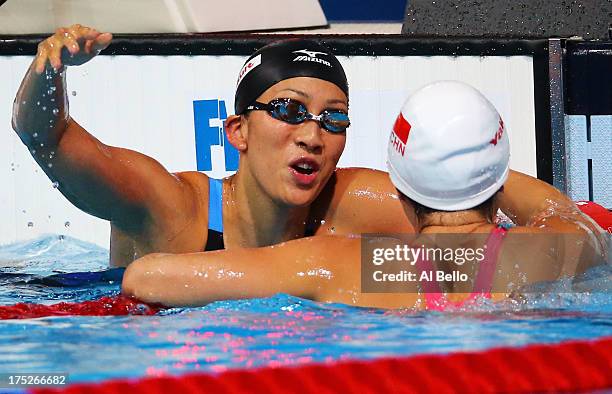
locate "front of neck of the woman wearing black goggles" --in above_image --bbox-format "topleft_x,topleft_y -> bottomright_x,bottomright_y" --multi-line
223,171 -> 309,248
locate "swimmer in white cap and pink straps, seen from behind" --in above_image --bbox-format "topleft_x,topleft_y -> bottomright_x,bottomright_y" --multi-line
123,81 -> 605,310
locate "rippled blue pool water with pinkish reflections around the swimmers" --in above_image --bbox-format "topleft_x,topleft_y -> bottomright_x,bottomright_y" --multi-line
0,236 -> 612,383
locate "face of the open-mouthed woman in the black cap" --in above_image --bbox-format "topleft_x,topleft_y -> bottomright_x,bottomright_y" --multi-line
241,77 -> 348,206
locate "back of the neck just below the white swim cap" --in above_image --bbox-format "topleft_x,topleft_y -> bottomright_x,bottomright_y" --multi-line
419,209 -> 491,233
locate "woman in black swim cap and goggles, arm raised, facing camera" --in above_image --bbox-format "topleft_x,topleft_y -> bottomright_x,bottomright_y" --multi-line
13,25 -> 600,265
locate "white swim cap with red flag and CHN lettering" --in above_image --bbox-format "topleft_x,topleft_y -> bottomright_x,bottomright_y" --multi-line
387,81 -> 510,211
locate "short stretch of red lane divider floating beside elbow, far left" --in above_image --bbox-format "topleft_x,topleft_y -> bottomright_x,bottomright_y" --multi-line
0,295 -> 160,320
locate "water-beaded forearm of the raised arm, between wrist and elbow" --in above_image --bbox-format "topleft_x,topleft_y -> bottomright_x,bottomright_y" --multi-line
12,62 -> 69,152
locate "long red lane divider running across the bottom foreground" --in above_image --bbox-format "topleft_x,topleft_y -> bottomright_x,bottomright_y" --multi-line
33,337 -> 612,394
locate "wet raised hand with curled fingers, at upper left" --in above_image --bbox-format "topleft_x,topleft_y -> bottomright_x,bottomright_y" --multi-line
35,24 -> 113,74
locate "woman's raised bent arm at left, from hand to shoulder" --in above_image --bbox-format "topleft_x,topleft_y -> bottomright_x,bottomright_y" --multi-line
12,25 -> 203,242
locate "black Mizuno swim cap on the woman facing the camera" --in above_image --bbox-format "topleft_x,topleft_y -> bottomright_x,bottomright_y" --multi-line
234,39 -> 348,115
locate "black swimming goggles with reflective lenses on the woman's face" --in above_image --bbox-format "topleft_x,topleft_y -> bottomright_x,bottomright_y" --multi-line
246,98 -> 351,133
